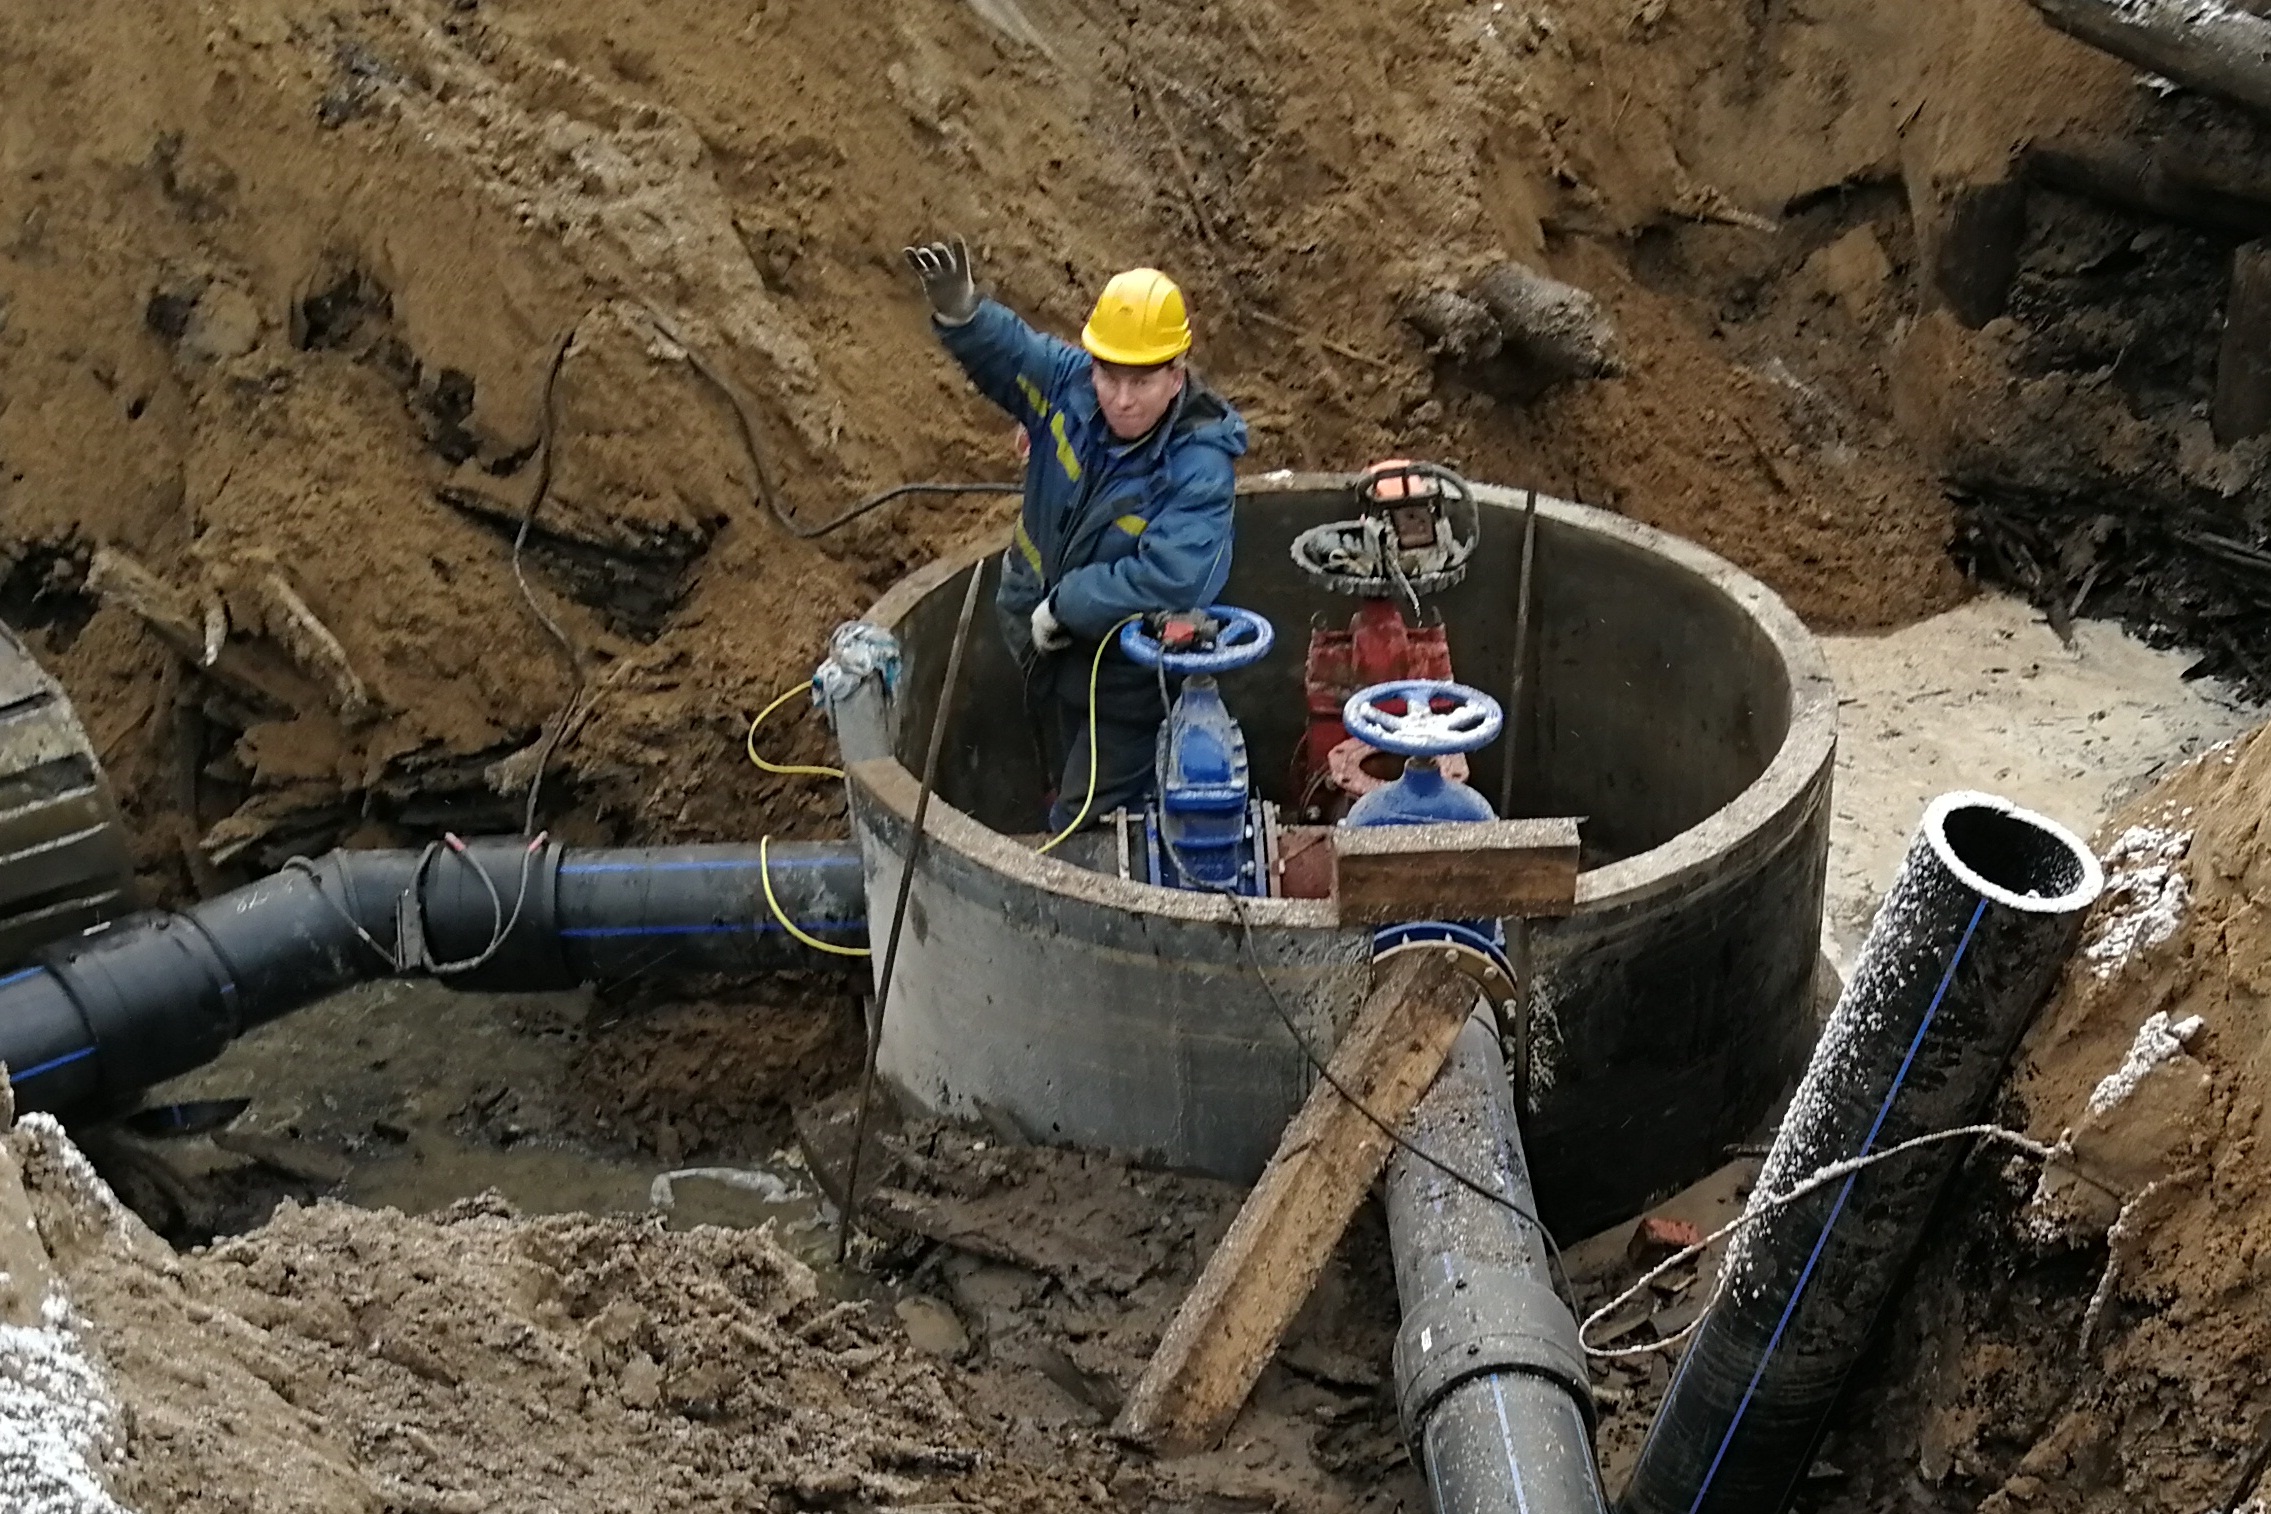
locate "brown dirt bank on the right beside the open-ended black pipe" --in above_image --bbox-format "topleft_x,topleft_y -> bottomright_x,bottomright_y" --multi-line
1828,731 -> 2271,1514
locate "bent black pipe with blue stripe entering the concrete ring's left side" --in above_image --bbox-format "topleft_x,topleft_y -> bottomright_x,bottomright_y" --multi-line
0,838 -> 868,1112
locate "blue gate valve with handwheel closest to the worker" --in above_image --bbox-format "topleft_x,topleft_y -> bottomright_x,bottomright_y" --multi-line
1120,606 -> 1276,894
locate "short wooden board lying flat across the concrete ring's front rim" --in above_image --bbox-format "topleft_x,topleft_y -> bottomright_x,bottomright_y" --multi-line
1333,819 -> 1578,926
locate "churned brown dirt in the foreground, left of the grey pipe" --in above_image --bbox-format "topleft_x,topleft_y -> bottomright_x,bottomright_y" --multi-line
0,1103 -> 1419,1514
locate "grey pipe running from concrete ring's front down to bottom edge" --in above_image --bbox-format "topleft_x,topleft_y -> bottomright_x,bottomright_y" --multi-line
1388,1015 -> 1603,1514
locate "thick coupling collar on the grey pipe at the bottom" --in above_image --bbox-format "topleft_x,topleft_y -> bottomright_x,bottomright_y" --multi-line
1394,1258 -> 1594,1446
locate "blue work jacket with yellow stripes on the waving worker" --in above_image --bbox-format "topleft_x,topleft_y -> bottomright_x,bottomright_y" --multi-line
938,300 -> 1247,672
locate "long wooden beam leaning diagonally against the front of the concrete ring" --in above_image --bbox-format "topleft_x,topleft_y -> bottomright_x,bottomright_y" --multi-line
1115,953 -> 1476,1450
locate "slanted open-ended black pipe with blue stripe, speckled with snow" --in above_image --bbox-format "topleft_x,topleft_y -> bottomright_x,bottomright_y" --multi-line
1619,794 -> 2103,1514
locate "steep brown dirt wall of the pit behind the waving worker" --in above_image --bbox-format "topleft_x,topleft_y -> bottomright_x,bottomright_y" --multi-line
0,0 -> 2152,888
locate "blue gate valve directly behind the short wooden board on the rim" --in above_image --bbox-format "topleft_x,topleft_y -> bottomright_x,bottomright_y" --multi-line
1340,679 -> 1512,981
